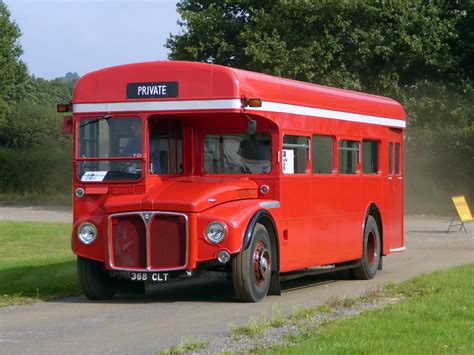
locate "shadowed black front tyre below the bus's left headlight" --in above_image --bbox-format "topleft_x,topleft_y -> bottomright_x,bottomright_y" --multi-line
77,256 -> 120,300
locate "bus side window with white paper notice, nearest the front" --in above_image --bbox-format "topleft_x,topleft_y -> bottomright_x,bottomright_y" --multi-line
282,136 -> 309,174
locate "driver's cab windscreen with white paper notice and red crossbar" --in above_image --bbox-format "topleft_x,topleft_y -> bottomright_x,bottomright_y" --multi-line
77,116 -> 143,182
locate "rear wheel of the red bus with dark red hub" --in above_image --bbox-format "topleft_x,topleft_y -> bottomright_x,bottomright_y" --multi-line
353,215 -> 381,280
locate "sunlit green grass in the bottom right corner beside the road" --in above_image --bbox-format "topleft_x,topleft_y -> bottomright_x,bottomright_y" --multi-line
264,265 -> 474,354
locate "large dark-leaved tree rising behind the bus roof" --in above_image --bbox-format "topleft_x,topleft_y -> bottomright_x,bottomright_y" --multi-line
166,0 -> 466,95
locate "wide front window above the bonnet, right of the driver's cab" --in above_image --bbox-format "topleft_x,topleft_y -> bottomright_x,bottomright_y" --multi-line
204,133 -> 272,174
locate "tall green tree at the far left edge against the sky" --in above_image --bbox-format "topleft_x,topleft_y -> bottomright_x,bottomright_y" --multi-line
0,0 -> 27,121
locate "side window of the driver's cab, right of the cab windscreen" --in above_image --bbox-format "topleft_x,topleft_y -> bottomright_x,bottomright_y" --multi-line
149,117 -> 183,174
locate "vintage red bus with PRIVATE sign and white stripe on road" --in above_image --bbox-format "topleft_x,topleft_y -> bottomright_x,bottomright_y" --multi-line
59,61 -> 405,302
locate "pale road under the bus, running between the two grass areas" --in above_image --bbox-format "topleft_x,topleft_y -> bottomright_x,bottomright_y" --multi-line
0,217 -> 474,354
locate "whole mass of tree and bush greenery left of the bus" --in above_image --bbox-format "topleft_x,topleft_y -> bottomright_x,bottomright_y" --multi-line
0,0 -> 75,195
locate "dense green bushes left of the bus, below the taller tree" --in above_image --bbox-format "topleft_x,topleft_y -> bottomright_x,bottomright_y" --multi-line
0,69 -> 77,199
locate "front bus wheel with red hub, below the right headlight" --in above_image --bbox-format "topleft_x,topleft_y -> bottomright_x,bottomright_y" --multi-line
232,223 -> 272,302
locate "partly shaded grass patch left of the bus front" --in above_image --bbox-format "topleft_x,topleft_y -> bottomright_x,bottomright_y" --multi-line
0,221 -> 79,306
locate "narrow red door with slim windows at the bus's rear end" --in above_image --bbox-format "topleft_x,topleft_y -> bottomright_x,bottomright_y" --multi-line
387,129 -> 404,251
